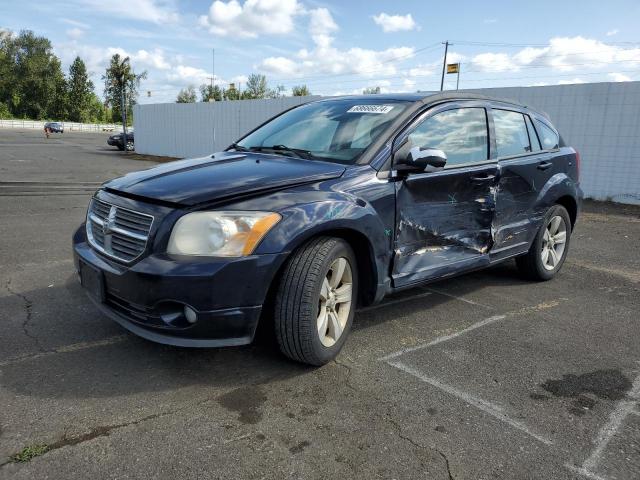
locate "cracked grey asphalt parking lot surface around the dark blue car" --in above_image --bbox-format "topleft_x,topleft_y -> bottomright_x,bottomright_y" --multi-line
0,130 -> 640,480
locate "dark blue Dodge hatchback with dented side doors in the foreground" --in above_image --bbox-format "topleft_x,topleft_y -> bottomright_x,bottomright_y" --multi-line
73,93 -> 582,365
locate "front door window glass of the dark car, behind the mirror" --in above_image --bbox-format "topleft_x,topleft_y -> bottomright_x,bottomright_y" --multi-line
409,107 -> 489,166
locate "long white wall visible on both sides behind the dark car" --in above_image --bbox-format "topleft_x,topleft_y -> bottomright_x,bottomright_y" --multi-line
134,82 -> 640,204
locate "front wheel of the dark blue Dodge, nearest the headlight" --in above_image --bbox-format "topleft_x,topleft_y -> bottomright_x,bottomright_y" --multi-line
274,237 -> 358,365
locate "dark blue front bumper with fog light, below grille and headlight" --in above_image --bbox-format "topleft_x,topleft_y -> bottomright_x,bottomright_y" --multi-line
73,225 -> 286,347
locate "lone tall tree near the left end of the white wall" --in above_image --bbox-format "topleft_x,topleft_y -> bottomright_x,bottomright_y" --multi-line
102,53 -> 147,129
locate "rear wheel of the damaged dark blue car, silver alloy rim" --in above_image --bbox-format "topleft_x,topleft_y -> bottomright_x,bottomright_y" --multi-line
516,205 -> 571,280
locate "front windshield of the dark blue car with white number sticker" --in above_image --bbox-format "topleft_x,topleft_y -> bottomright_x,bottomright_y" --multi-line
232,98 -> 408,164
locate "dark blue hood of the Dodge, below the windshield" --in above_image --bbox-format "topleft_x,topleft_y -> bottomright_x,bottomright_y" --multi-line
103,152 -> 345,206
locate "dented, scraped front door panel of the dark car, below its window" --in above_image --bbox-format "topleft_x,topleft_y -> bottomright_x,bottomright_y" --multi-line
393,164 -> 498,285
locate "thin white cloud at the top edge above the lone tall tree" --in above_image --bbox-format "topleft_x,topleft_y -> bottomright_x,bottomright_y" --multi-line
80,0 -> 180,24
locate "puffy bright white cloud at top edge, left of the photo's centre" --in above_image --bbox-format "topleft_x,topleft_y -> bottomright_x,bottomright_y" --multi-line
199,0 -> 304,38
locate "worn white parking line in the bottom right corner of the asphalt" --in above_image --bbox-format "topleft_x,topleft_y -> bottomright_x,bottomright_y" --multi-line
566,375 -> 640,479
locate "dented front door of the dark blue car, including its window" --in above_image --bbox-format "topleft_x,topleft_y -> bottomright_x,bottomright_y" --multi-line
392,102 -> 498,287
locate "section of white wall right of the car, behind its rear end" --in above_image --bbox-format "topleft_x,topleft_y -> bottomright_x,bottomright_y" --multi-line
464,82 -> 640,204
